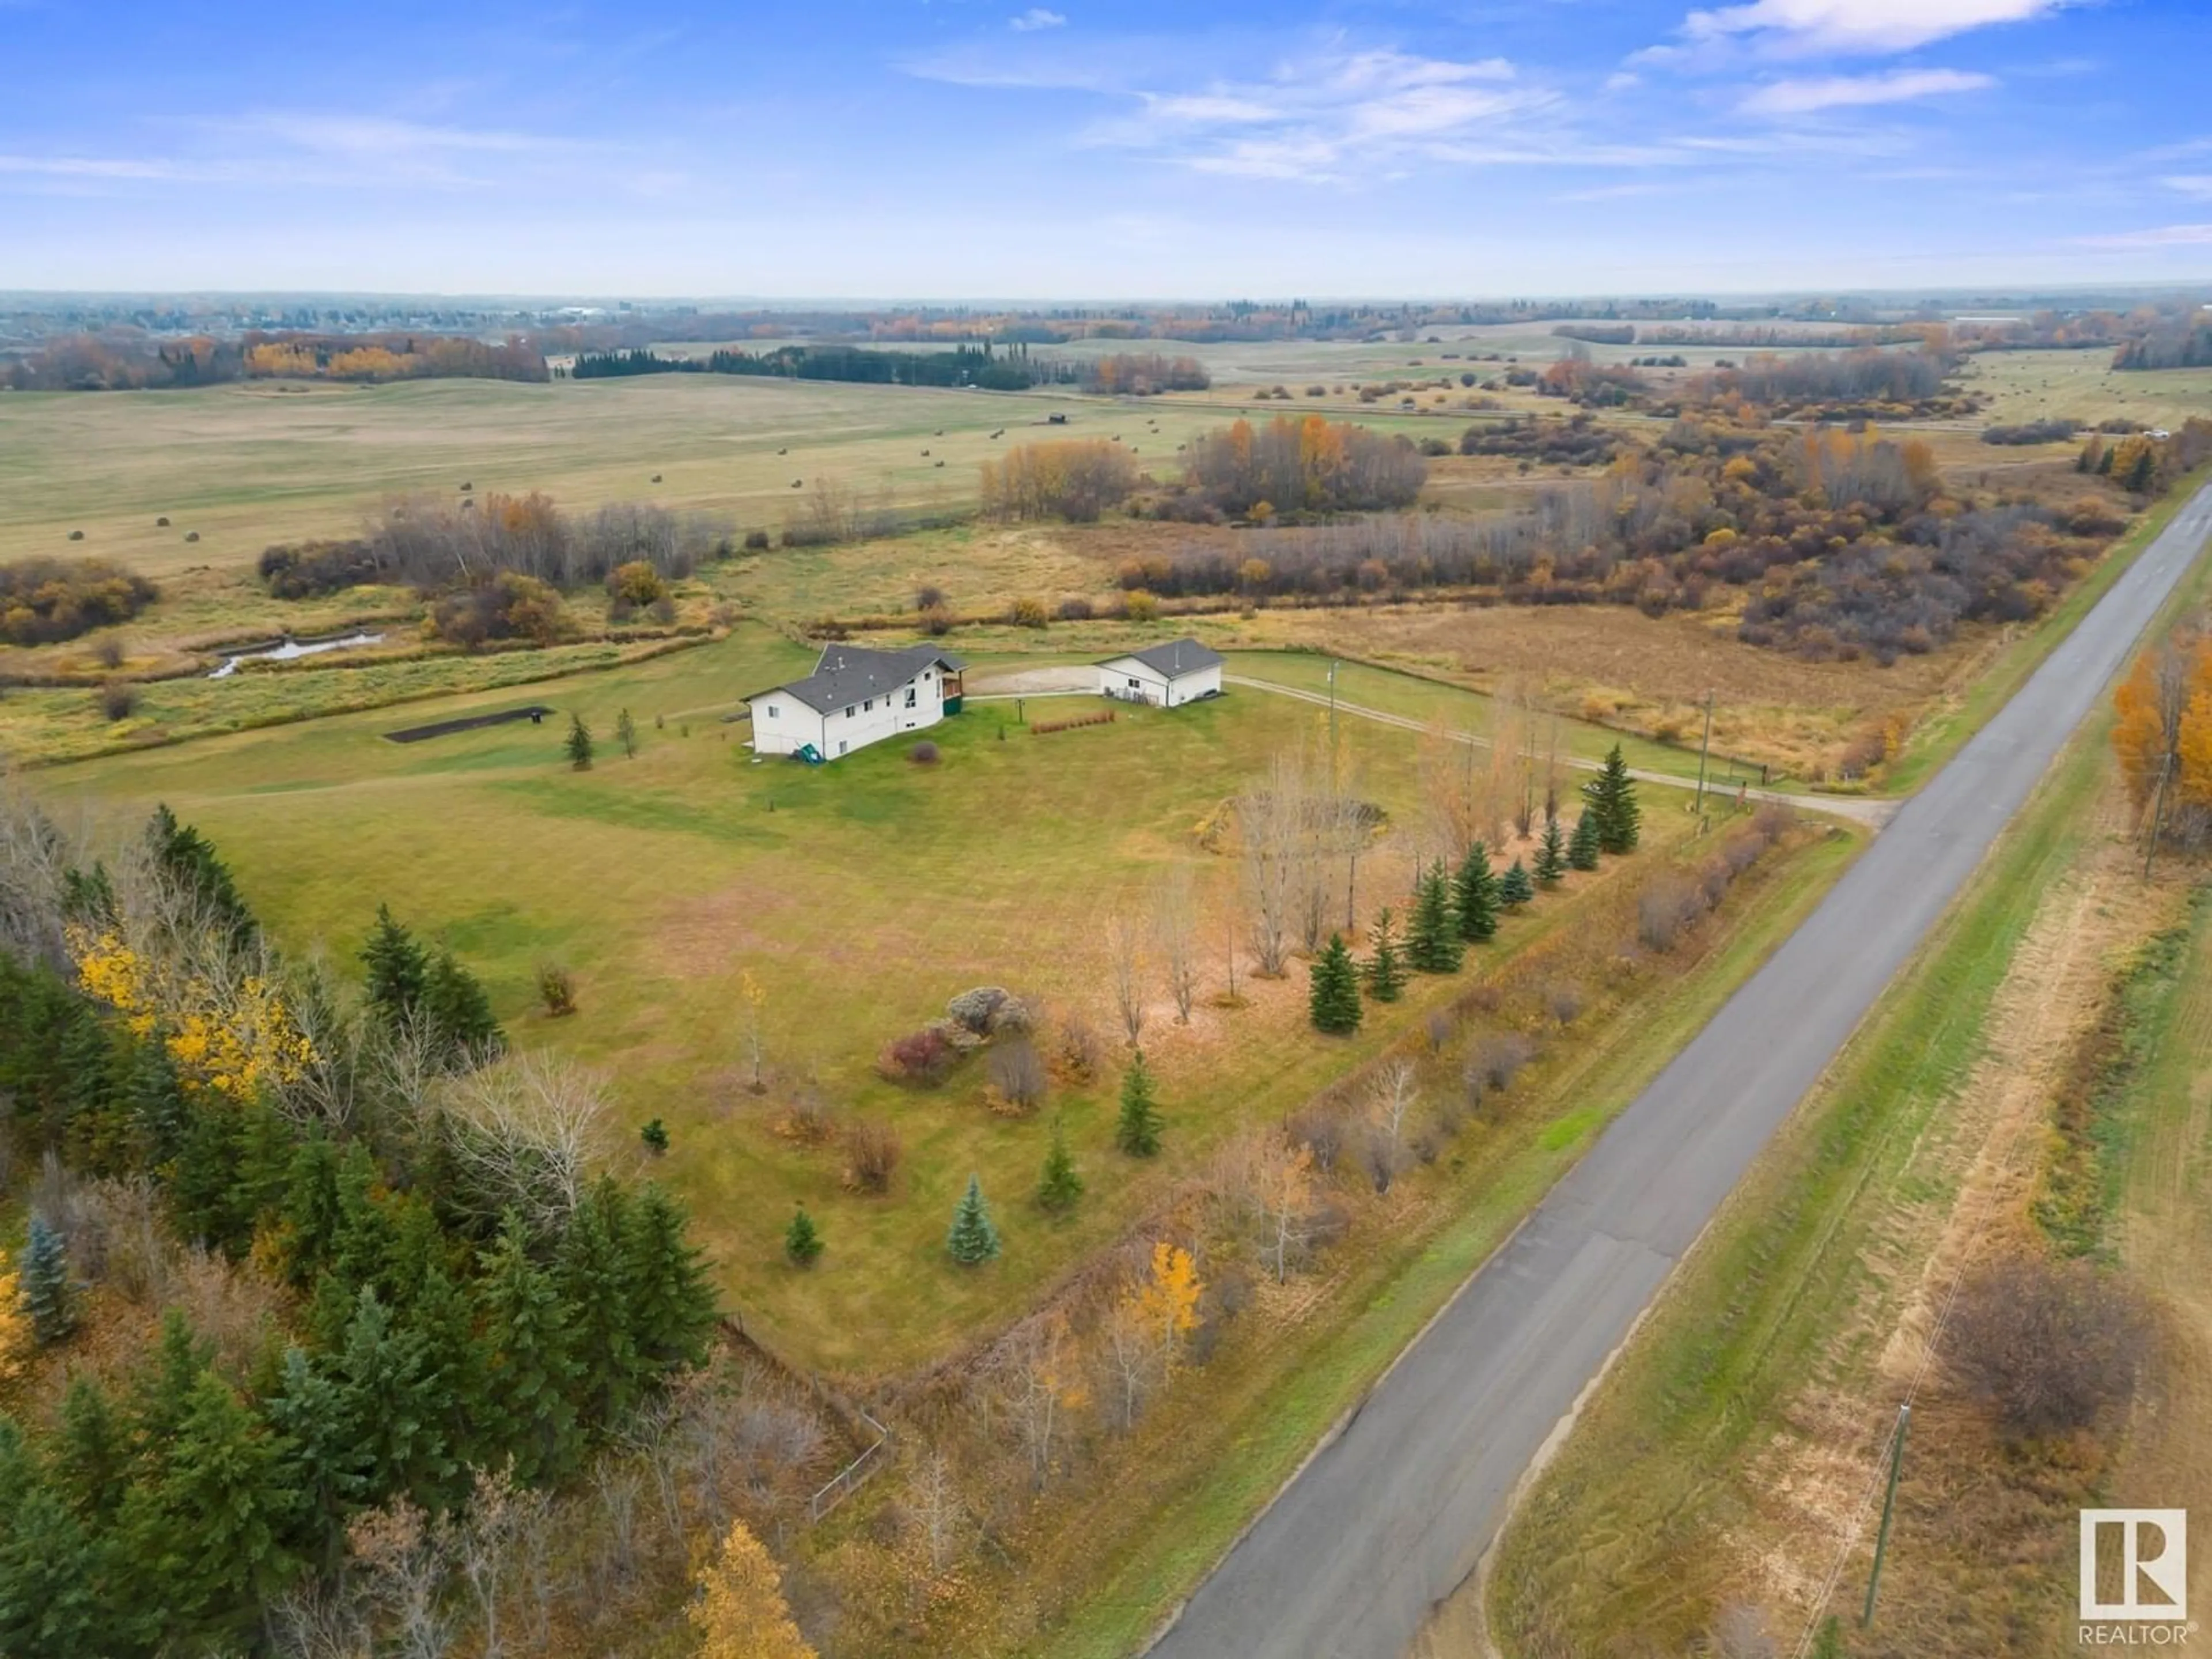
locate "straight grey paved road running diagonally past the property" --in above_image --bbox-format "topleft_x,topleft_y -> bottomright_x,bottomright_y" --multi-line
1154,489 -> 2212,1659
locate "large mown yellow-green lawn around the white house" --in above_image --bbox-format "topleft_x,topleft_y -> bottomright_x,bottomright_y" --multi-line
37,628 -> 1716,1374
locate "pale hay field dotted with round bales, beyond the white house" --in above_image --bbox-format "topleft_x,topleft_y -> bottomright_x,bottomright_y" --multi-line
0,374 -> 1247,577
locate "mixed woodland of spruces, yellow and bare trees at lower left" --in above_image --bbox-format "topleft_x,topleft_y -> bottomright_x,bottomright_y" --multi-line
0,798 -> 714,1659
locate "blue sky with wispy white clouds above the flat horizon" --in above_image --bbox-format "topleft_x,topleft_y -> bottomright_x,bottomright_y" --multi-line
0,0 -> 2212,298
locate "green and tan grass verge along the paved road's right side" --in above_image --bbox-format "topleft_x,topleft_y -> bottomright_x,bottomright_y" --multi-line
1462,646 -> 2203,1659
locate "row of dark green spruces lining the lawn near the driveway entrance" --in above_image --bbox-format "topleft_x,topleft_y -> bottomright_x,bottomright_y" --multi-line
1307,743 -> 1643,1035
